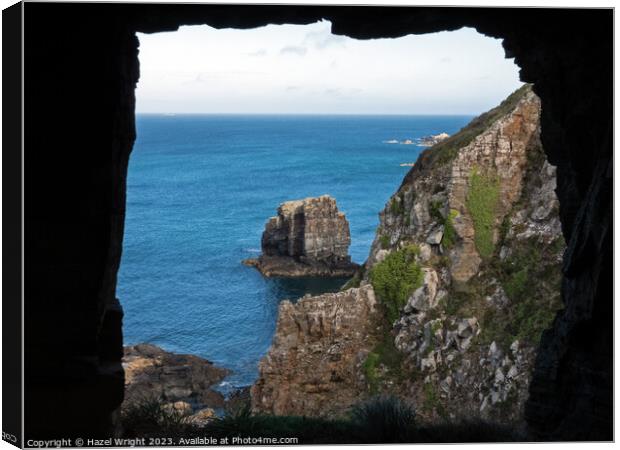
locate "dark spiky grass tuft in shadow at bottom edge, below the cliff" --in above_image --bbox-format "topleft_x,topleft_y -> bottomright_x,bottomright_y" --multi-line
350,396 -> 415,443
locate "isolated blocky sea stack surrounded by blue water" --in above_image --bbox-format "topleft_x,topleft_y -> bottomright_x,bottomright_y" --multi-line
243,195 -> 359,278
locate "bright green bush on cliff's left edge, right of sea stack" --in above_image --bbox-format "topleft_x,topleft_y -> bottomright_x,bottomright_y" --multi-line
370,245 -> 423,323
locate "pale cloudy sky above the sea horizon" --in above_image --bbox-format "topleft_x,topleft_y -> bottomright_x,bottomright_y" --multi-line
136,21 -> 522,114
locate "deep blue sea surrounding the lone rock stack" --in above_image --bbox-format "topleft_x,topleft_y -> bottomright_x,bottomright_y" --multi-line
118,115 -> 471,386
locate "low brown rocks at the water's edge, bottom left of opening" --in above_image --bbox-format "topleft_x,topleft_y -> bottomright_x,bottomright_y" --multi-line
123,344 -> 229,420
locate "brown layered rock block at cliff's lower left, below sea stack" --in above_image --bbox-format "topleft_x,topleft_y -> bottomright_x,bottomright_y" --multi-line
252,286 -> 377,416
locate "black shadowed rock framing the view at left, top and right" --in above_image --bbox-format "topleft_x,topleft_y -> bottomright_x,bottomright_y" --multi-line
24,3 -> 613,439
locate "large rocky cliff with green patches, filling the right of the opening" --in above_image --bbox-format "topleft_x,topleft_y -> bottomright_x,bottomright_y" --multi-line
253,86 -> 565,424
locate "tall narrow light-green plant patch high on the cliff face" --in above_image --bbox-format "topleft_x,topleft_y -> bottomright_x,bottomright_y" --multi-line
465,169 -> 499,259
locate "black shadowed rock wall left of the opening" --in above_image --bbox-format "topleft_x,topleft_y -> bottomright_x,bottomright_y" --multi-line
24,3 -> 138,438
